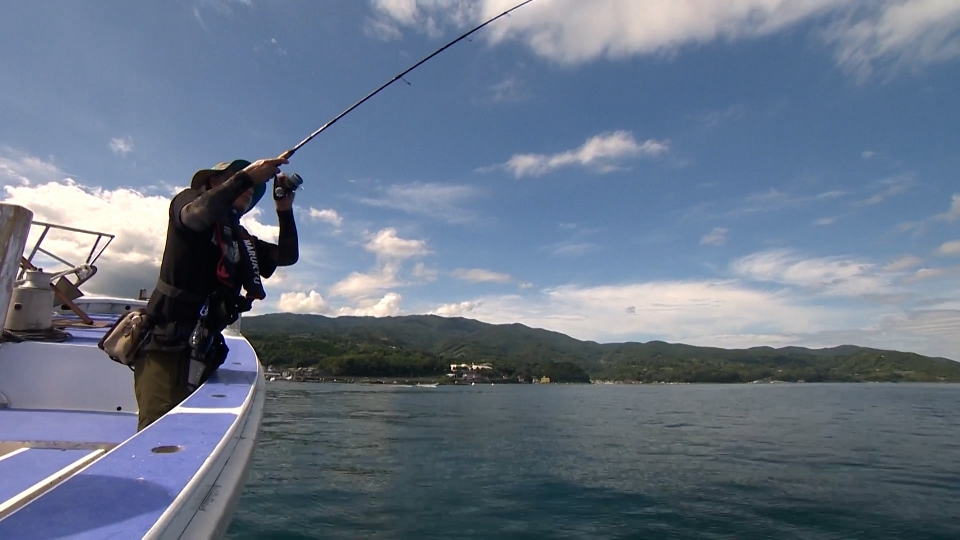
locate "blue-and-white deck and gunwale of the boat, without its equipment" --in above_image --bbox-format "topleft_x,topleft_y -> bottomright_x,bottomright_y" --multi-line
0,308 -> 263,539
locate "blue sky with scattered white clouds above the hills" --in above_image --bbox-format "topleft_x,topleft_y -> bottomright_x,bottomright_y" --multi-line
0,0 -> 960,360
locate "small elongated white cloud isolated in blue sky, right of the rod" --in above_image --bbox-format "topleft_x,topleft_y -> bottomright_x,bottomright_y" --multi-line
502,131 -> 670,178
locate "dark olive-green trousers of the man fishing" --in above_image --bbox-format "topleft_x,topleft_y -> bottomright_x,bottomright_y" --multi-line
133,350 -> 190,432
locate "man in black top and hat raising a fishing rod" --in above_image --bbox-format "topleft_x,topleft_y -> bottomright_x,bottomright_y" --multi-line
133,157 -> 299,431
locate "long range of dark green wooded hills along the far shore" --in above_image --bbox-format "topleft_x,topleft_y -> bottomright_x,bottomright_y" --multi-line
242,314 -> 960,383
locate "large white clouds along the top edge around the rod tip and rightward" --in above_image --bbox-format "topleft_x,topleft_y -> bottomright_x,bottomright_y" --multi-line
373,0 -> 960,81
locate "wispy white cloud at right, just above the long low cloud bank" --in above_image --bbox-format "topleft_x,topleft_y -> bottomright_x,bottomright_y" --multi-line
731,250 -> 891,296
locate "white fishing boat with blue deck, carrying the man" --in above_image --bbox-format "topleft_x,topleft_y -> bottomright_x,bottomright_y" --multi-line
0,203 -> 265,539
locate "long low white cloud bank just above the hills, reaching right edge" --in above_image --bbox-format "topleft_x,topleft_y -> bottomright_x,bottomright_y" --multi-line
374,276 -> 960,359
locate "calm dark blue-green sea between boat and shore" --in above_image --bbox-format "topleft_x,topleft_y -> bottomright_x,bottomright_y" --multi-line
228,382 -> 960,540
